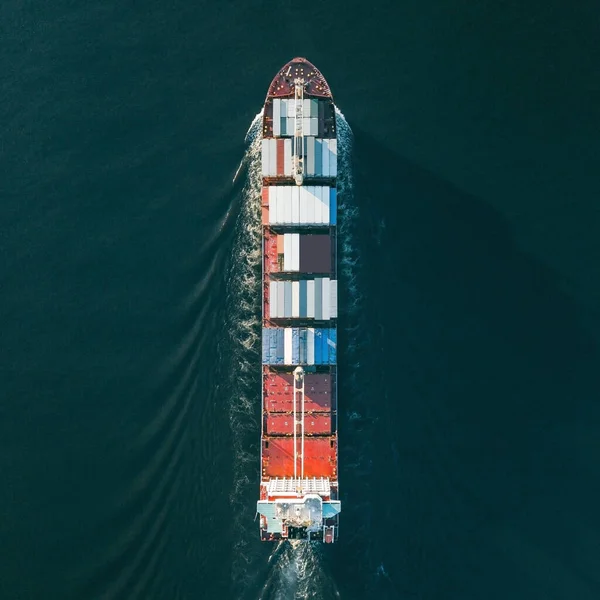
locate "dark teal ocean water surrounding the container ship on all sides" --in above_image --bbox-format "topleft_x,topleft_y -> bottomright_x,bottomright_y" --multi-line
0,0 -> 600,600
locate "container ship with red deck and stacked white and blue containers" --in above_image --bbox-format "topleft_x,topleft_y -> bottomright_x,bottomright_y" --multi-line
257,58 -> 341,543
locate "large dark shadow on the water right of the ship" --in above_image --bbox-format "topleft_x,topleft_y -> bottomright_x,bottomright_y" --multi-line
325,130 -> 599,599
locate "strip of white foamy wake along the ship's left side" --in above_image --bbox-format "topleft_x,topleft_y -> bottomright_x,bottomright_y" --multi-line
219,113 -> 262,593
